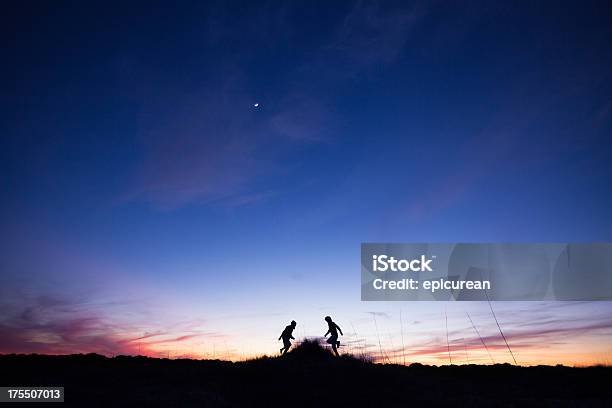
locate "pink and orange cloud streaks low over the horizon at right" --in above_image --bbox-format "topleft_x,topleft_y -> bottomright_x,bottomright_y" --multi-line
378,302 -> 612,364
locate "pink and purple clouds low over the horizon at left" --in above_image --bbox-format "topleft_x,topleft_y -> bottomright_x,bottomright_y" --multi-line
0,296 -> 225,356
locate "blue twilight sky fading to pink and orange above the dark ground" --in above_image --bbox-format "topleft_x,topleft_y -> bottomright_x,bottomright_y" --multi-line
0,1 -> 612,365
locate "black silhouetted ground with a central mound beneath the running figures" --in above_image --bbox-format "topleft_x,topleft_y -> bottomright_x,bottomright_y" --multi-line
0,343 -> 612,407
